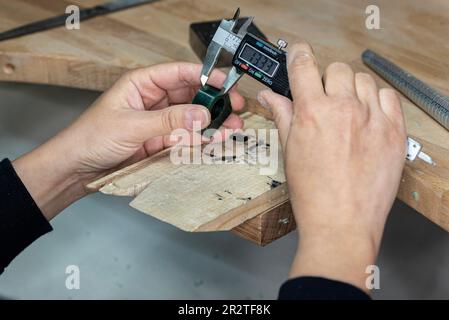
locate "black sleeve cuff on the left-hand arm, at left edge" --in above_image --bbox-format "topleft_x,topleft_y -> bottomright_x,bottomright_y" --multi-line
0,159 -> 53,274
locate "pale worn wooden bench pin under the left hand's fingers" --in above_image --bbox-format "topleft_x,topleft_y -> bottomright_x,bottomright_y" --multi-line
88,112 -> 292,231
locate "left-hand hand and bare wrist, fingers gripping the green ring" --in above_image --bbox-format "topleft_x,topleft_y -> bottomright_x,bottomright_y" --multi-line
13,63 -> 244,219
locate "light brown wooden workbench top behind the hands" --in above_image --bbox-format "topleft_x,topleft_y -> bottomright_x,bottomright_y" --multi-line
0,0 -> 449,243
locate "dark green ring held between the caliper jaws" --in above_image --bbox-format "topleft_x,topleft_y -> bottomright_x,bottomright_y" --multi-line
192,84 -> 232,132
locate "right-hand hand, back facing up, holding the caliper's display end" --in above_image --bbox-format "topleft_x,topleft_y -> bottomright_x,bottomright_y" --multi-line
258,43 -> 407,290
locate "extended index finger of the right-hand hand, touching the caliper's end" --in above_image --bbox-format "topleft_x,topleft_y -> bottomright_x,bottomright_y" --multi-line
287,42 -> 324,102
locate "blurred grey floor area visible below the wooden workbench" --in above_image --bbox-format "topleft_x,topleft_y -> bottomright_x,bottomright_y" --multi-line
0,83 -> 449,299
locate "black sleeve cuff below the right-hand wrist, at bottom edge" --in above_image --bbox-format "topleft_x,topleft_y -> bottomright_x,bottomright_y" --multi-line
279,277 -> 371,300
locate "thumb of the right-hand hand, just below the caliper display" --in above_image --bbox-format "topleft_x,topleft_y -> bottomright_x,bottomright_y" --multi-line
257,90 -> 293,150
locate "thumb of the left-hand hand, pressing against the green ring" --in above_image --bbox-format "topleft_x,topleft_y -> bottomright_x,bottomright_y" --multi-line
137,104 -> 210,139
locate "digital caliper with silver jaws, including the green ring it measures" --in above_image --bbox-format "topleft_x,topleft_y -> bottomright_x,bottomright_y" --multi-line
193,9 -> 291,129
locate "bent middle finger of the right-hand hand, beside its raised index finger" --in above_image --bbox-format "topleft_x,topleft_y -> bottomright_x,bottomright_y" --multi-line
323,62 -> 356,97
